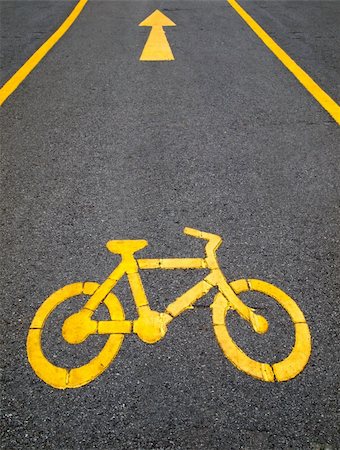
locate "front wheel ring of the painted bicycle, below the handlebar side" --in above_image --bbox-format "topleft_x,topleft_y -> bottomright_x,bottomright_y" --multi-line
212,279 -> 312,381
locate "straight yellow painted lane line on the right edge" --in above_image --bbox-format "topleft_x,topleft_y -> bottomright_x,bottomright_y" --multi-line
227,0 -> 340,125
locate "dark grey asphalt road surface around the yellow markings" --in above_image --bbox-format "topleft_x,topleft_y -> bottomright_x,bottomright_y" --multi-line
0,0 -> 340,450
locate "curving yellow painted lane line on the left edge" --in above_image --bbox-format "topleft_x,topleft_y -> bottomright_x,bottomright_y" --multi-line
0,0 -> 88,105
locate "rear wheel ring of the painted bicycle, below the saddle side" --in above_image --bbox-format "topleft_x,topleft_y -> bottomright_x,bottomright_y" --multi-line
27,282 -> 125,389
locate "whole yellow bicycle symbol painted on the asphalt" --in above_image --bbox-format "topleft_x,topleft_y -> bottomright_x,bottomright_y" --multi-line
27,228 -> 311,389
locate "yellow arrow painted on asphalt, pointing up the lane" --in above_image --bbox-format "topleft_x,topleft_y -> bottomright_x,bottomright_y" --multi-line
139,9 -> 176,61
